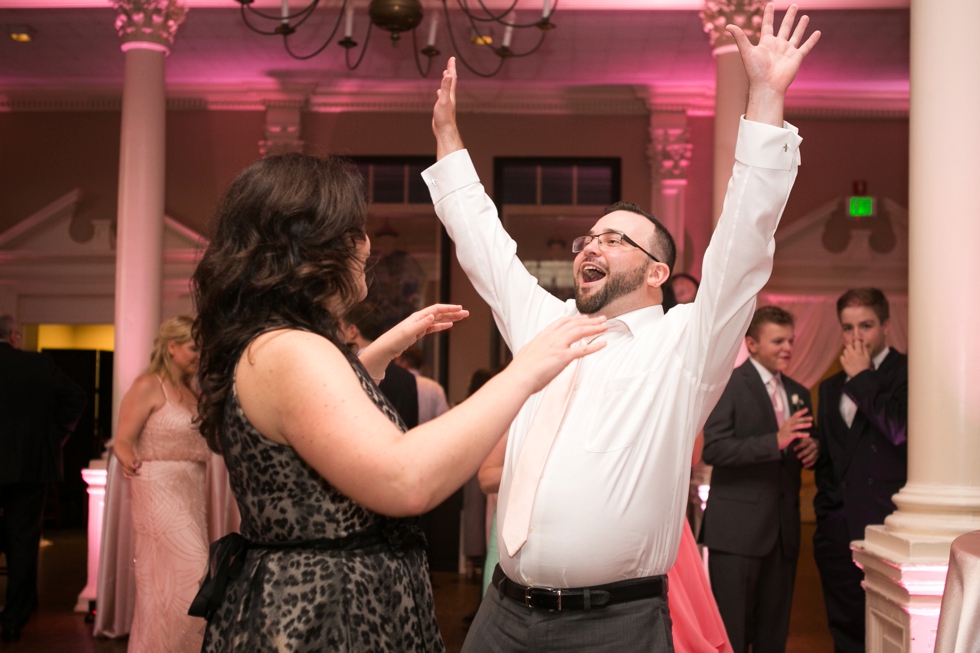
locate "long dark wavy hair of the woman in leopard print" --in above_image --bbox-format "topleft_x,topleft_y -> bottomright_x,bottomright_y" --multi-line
192,154 -> 367,451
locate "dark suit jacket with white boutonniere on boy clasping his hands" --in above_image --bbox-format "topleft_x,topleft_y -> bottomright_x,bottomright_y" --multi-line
702,360 -> 812,558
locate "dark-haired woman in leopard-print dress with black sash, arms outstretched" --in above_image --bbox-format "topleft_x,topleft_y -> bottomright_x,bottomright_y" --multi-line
192,150 -> 605,652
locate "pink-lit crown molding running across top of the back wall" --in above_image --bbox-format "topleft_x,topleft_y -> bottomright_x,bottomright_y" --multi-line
0,84 -> 909,121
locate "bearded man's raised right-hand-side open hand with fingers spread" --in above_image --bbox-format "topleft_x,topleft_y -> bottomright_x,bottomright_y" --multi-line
726,2 -> 820,127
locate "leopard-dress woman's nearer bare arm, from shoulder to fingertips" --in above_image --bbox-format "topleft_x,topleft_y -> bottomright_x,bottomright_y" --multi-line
236,317 -> 606,516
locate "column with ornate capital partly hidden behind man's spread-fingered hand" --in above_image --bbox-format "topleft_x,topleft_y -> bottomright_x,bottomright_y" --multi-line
701,0 -> 765,225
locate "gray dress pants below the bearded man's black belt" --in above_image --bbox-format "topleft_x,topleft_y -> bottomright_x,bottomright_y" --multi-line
463,585 -> 674,653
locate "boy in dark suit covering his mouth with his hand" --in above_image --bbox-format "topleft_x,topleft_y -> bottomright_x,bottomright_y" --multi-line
813,288 -> 908,653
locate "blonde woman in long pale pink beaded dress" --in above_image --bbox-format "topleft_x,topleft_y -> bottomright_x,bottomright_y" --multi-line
112,316 -> 211,653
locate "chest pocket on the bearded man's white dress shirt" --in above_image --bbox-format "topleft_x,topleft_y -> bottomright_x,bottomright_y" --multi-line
585,372 -> 650,453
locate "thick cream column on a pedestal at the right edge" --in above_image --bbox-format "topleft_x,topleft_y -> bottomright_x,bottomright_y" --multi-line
852,0 -> 980,653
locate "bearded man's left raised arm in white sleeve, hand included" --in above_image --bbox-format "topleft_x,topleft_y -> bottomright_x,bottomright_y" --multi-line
422,57 -> 575,353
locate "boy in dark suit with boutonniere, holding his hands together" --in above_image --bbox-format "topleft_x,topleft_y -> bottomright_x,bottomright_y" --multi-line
702,306 -> 817,653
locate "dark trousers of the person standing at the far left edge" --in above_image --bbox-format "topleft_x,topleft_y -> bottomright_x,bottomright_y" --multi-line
0,483 -> 45,629
